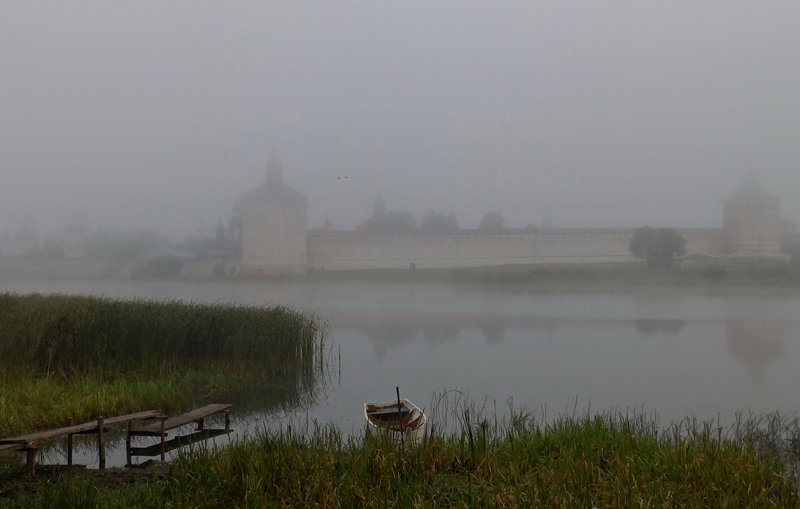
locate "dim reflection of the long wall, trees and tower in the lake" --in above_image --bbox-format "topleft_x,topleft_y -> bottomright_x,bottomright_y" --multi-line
333,310 -> 790,390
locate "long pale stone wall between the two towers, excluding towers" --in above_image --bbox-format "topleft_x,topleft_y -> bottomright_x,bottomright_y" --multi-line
307,229 -> 723,270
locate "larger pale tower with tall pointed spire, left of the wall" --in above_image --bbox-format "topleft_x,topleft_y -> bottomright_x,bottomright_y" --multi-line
242,151 -> 308,274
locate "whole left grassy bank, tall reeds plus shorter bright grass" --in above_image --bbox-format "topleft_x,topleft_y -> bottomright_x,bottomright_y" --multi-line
0,294 -> 323,436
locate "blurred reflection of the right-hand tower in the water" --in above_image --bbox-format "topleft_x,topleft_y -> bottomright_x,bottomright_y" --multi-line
725,320 -> 786,380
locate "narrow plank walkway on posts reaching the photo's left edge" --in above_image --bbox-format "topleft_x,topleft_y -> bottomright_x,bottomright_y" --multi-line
0,410 -> 161,477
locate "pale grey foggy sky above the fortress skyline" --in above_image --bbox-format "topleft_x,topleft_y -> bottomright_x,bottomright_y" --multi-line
0,0 -> 800,235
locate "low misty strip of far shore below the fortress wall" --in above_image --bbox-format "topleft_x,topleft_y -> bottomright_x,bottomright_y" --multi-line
0,259 -> 800,290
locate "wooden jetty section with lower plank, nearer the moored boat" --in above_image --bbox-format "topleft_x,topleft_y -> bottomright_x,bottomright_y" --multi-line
125,403 -> 233,466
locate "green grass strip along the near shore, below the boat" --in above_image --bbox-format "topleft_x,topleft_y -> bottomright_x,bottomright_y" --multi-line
9,415 -> 800,508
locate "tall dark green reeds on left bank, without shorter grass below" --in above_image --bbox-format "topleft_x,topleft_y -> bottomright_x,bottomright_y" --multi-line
0,293 -> 322,377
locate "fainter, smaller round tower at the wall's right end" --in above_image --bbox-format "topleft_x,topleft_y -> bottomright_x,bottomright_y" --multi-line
722,176 -> 781,256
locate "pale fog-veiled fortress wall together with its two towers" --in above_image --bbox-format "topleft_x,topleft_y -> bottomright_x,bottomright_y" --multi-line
242,158 -> 786,274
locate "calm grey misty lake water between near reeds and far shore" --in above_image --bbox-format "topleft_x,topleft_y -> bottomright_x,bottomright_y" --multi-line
0,281 -> 800,464
